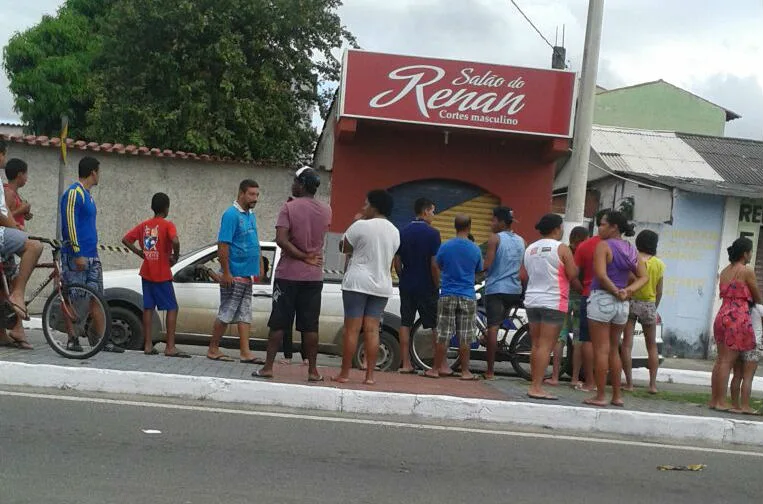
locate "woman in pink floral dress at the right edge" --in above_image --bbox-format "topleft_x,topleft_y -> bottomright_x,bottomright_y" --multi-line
709,238 -> 761,410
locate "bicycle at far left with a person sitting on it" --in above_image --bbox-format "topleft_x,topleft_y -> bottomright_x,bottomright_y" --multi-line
13,236 -> 111,359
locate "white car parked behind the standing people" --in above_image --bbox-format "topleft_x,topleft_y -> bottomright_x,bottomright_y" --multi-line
103,242 -> 662,376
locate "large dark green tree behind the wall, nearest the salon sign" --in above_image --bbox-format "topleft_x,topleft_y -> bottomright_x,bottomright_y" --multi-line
87,0 -> 354,162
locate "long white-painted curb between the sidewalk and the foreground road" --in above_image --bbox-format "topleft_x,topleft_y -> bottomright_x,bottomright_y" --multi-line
0,362 -> 763,446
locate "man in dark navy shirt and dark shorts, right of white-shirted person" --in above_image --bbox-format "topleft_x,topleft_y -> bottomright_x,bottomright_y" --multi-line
394,198 -> 444,378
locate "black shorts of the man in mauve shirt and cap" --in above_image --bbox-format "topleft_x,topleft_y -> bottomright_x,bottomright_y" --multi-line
268,278 -> 323,332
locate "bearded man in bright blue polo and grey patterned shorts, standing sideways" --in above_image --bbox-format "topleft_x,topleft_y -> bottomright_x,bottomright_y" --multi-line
207,179 -> 264,364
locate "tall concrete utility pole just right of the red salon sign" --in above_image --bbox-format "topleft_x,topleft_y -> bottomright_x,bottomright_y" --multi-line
565,0 -> 604,231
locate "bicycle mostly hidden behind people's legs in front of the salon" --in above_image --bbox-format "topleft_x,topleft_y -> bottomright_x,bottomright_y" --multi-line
410,285 -> 572,381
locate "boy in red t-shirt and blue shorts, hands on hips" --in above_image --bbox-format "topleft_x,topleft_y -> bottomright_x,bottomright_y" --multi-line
122,193 -> 190,358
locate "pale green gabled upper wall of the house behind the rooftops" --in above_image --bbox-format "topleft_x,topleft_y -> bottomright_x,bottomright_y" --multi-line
594,81 -> 726,136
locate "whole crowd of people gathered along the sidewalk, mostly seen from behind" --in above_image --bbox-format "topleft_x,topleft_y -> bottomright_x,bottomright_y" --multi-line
0,142 -> 763,413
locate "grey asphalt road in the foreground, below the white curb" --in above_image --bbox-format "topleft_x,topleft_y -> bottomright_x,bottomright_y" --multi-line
0,390 -> 763,504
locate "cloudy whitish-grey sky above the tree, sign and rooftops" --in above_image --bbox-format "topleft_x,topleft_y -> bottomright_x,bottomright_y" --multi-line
0,0 -> 763,139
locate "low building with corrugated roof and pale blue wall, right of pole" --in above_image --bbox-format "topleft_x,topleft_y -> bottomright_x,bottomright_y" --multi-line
554,126 -> 763,357
